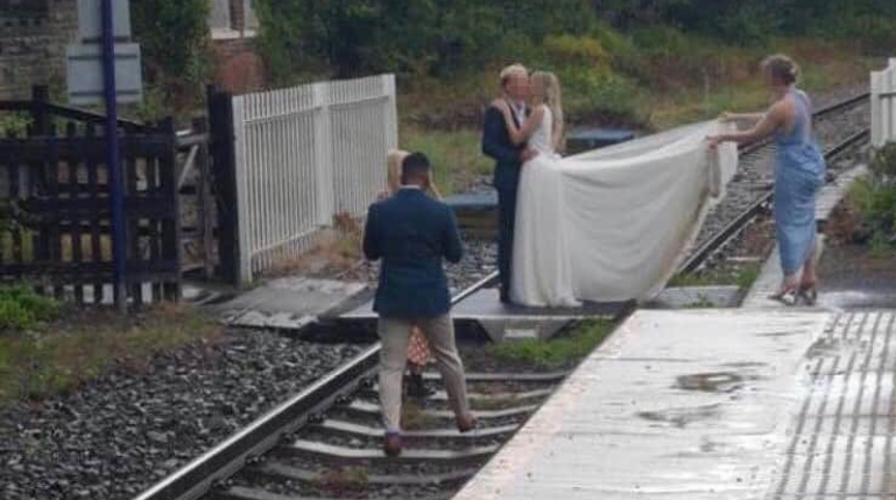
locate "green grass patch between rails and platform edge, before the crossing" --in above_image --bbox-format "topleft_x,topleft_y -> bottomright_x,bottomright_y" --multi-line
492,320 -> 614,369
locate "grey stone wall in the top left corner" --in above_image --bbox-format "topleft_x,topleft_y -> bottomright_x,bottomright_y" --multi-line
0,0 -> 78,99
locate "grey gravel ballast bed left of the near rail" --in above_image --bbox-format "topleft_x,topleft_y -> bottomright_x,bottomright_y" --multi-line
0,331 -> 362,500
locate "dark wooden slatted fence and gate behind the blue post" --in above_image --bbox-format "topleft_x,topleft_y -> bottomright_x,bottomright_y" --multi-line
0,90 -> 207,303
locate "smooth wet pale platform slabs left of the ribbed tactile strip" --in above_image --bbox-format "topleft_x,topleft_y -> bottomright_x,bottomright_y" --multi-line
455,310 -> 836,500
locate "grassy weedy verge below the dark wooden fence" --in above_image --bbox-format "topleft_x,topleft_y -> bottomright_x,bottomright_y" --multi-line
0,304 -> 220,406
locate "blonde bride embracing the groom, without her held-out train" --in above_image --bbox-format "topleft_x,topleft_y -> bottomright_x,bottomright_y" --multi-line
494,71 -> 580,307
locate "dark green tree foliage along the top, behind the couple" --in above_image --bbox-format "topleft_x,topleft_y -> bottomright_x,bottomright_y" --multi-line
252,0 -> 896,80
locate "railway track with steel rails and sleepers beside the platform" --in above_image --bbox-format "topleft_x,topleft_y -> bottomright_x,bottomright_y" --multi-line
137,90 -> 868,500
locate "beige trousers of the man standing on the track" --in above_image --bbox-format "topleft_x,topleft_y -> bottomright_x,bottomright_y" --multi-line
377,314 -> 470,432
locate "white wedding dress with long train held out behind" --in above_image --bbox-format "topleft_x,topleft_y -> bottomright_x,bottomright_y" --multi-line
511,110 -> 738,307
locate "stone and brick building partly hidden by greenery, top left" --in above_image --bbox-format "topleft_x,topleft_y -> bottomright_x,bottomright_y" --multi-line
0,0 -> 265,99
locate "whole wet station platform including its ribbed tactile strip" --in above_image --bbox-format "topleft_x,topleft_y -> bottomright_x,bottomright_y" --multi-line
454,309 -> 896,500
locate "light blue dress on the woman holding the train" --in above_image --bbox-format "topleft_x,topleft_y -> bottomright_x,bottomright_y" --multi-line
775,89 -> 826,276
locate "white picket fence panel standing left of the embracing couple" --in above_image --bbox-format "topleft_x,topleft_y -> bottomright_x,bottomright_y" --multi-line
233,75 -> 398,283
